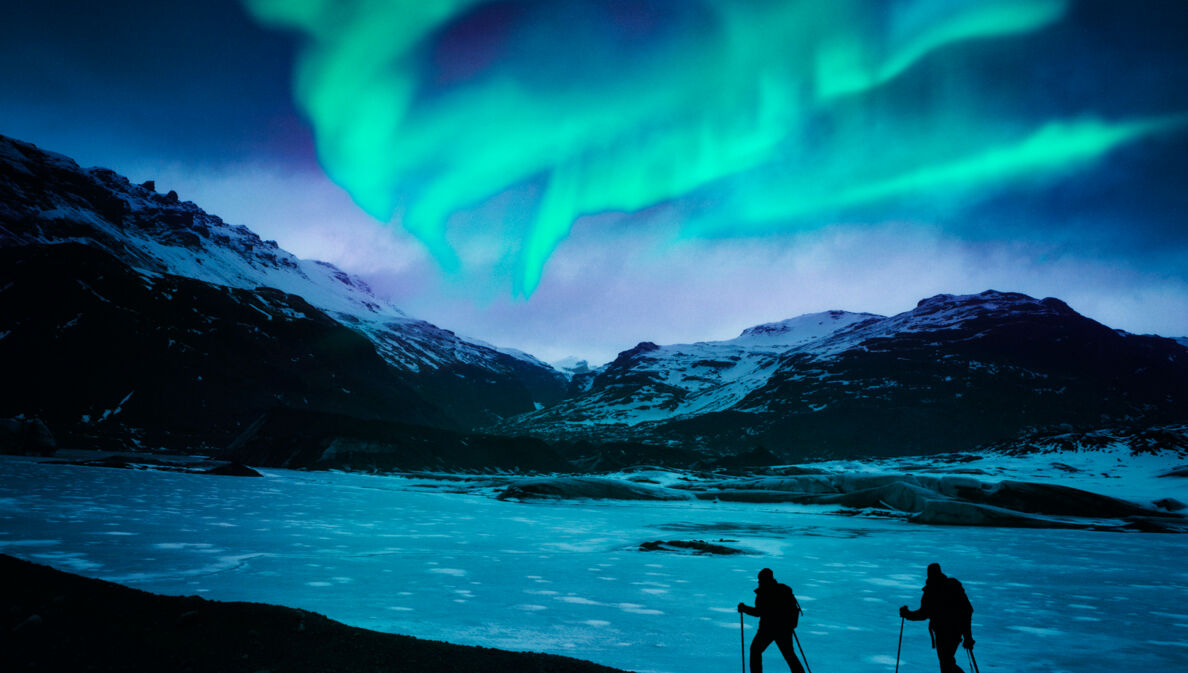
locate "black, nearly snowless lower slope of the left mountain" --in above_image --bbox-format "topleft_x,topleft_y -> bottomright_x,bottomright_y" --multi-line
0,244 -> 447,449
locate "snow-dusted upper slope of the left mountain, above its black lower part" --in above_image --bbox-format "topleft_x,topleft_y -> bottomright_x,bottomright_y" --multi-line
0,136 -> 564,395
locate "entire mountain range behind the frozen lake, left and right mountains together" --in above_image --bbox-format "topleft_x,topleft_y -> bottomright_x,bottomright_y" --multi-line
0,136 -> 1188,466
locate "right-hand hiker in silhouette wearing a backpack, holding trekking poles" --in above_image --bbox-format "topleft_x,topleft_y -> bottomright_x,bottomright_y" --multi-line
899,564 -> 973,673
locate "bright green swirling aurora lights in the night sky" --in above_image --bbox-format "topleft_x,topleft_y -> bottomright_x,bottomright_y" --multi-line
244,0 -> 1184,297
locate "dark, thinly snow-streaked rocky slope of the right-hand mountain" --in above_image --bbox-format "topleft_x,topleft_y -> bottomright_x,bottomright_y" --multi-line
703,293 -> 1188,455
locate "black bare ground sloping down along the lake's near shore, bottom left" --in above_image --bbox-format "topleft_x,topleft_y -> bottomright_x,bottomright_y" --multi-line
0,555 -> 632,673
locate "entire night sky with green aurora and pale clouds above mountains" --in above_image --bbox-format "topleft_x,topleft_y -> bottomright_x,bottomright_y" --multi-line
0,0 -> 1188,361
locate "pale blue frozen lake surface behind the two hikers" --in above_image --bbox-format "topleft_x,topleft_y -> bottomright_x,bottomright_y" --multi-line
0,457 -> 1188,673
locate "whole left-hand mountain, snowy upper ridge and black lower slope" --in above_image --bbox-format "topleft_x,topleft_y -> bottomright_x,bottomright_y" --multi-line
0,137 -> 567,454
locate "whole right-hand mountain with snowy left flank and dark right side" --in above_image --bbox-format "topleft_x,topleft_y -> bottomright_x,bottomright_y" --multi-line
500,290 -> 1188,458
